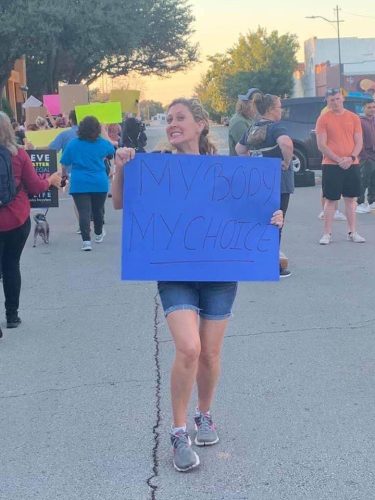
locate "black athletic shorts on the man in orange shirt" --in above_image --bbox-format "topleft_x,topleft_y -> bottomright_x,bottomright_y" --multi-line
322,165 -> 361,201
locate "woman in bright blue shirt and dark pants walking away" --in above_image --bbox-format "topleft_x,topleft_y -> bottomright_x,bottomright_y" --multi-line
61,116 -> 115,251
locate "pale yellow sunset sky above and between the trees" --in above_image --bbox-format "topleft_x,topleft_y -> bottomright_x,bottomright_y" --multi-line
108,0 -> 375,104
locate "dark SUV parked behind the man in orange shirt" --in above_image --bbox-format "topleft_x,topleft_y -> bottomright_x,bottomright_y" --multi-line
281,96 -> 372,172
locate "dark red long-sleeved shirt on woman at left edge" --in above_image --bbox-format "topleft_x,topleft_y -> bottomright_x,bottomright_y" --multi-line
0,148 -> 49,231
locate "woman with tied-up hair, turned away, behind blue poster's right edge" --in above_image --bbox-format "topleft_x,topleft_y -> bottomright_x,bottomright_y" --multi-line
236,93 -> 294,278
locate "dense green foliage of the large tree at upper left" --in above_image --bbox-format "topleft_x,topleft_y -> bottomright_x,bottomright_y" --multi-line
0,0 -> 197,96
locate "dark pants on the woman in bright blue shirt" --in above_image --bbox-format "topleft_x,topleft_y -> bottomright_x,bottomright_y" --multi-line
72,193 -> 107,241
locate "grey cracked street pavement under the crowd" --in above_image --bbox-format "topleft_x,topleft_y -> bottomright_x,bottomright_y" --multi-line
0,129 -> 375,500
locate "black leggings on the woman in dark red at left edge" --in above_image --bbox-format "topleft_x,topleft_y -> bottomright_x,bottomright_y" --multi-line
0,217 -> 31,317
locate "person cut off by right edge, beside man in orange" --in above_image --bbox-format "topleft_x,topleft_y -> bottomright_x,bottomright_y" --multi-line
356,101 -> 375,214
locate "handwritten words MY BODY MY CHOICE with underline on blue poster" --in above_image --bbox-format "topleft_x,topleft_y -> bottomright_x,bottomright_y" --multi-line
125,155 -> 280,259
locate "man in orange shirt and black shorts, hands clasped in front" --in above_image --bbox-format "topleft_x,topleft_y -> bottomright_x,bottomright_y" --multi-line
316,89 -> 366,245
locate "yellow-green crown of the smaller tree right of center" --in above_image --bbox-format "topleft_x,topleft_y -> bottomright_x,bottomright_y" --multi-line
196,28 -> 298,119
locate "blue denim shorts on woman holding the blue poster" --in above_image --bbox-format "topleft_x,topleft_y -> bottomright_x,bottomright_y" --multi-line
158,281 -> 237,320
